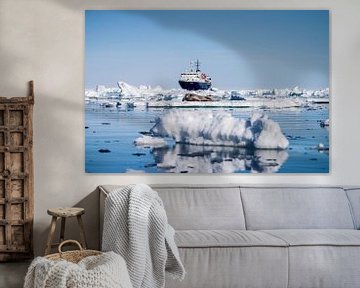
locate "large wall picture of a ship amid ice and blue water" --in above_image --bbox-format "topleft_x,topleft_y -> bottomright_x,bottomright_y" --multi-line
84,10 -> 331,174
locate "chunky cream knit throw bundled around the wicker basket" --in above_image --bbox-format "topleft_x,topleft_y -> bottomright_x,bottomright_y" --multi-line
24,252 -> 132,288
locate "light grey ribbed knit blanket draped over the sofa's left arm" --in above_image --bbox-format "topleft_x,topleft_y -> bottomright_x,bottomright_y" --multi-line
102,184 -> 185,288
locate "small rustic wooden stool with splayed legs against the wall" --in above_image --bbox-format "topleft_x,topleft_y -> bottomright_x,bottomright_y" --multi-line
45,207 -> 87,255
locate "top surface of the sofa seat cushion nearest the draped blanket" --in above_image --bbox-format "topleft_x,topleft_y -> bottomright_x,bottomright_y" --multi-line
175,230 -> 288,248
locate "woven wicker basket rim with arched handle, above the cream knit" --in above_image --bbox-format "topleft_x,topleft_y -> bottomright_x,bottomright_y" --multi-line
45,240 -> 102,263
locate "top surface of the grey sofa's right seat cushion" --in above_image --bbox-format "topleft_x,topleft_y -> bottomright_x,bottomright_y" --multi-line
262,229 -> 360,246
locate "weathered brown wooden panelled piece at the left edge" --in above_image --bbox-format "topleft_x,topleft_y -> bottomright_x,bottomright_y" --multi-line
0,81 -> 34,262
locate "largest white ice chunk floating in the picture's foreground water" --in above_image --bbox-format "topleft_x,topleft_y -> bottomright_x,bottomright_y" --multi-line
150,110 -> 289,149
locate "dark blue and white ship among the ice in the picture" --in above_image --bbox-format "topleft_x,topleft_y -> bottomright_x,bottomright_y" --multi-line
179,60 -> 211,90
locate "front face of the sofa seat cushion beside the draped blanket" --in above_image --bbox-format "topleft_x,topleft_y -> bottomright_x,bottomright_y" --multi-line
166,247 -> 288,288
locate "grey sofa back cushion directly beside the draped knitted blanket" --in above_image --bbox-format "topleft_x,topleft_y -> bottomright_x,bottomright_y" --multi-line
153,186 -> 245,230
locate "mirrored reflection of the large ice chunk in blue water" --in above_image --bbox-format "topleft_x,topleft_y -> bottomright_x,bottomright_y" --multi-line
151,144 -> 288,173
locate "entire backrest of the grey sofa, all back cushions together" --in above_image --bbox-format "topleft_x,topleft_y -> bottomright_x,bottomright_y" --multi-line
101,184 -> 360,230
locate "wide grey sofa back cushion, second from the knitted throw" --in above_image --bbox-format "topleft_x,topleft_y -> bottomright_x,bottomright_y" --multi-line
241,187 -> 355,230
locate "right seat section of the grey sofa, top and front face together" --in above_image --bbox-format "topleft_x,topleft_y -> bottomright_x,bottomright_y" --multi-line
263,229 -> 360,288
